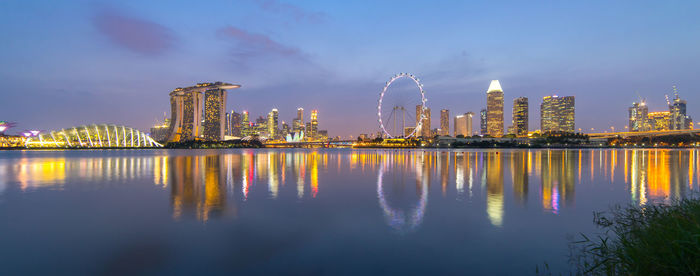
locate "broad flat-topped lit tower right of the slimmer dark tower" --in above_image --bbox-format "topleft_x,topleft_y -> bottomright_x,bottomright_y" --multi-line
540,95 -> 575,132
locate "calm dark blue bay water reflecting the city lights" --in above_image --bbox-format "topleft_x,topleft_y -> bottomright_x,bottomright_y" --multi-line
0,149 -> 700,275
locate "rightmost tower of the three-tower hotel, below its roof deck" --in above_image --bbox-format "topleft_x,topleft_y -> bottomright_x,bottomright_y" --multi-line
203,89 -> 226,141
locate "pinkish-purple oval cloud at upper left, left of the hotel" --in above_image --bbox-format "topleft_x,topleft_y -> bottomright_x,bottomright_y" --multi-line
92,10 -> 176,56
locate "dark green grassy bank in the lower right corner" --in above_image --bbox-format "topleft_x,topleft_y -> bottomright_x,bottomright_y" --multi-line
568,199 -> 700,275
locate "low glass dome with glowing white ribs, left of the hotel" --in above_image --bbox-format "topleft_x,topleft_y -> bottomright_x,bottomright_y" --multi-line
25,125 -> 163,148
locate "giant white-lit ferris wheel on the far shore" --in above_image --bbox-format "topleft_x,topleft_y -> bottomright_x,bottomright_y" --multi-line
377,73 -> 428,138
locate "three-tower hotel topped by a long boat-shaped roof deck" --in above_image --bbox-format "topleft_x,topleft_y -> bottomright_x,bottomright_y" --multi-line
166,82 -> 241,142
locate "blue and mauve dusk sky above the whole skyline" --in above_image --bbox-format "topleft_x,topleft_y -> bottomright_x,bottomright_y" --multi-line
0,0 -> 700,136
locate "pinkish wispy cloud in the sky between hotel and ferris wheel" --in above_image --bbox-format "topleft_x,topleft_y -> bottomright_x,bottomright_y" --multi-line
217,26 -> 306,65
